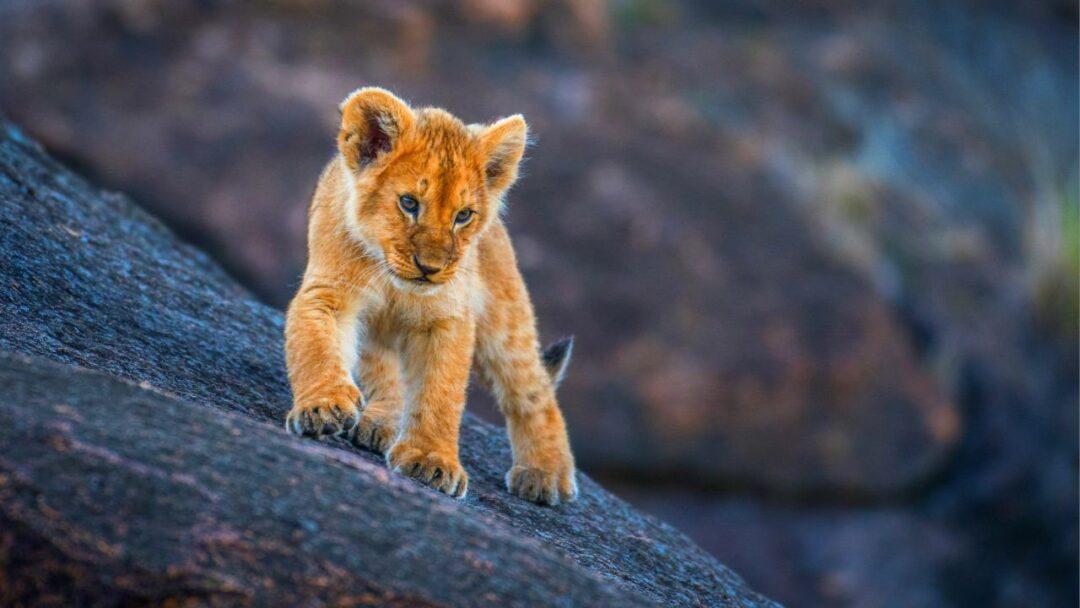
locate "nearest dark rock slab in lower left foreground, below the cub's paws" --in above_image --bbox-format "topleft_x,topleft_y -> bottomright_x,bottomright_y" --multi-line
0,354 -> 648,606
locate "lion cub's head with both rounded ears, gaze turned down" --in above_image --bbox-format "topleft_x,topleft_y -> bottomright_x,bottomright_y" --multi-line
338,87 -> 526,289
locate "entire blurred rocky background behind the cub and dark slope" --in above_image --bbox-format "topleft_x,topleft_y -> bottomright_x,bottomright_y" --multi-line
0,0 -> 1080,606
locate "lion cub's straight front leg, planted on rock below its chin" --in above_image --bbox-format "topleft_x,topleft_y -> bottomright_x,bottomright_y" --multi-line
387,319 -> 475,498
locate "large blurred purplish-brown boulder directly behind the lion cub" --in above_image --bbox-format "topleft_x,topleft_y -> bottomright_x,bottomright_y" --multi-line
0,1 -> 962,498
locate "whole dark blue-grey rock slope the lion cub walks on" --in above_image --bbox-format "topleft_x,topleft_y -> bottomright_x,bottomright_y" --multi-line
0,122 -> 772,606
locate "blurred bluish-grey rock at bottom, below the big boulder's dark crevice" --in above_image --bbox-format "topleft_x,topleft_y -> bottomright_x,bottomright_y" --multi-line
612,485 -> 972,608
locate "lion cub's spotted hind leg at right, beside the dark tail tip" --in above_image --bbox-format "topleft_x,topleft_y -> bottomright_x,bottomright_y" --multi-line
476,291 -> 578,504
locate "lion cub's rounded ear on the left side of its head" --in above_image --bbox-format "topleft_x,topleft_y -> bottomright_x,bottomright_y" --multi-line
338,86 -> 415,171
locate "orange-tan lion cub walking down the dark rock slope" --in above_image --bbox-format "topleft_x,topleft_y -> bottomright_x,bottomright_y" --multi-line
285,87 -> 578,504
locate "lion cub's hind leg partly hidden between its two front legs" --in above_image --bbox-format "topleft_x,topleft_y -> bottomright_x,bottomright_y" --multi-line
352,344 -> 405,454
